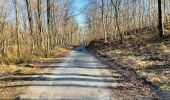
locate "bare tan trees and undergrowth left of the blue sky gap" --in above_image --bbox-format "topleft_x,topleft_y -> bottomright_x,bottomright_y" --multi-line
0,0 -> 81,57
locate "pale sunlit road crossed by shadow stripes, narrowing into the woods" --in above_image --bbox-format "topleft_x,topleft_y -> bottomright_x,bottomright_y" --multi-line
19,47 -> 121,100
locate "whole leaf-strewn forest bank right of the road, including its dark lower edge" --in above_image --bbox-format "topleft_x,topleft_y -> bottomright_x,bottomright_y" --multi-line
87,31 -> 170,100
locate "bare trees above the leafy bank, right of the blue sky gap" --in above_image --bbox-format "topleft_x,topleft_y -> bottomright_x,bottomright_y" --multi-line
86,0 -> 170,43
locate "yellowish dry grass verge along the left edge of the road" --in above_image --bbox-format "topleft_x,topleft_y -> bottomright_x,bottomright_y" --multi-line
0,48 -> 69,99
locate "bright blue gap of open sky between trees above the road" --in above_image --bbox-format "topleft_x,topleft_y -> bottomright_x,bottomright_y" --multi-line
73,0 -> 89,27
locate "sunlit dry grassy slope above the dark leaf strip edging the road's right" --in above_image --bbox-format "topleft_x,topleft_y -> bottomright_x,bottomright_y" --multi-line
87,32 -> 170,91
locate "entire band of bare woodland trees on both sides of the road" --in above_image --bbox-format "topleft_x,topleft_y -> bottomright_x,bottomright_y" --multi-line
0,0 -> 170,61
